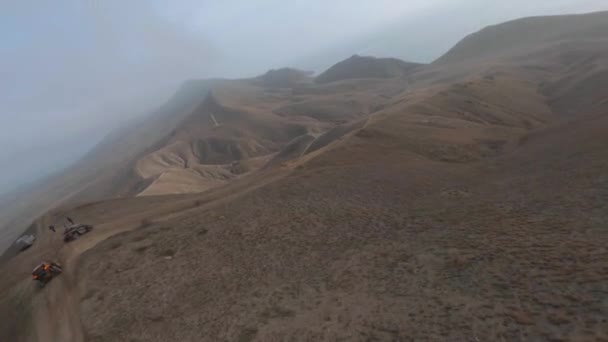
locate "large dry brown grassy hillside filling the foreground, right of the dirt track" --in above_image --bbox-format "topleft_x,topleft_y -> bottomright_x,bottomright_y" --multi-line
80,97 -> 608,341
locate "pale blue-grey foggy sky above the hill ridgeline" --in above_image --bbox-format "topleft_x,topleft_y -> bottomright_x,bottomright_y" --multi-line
0,0 -> 608,193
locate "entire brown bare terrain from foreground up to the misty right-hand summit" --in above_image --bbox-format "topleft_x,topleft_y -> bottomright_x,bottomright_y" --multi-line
0,9 -> 608,341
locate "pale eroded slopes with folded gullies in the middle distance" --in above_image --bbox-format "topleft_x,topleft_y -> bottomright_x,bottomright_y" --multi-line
135,76 -> 402,196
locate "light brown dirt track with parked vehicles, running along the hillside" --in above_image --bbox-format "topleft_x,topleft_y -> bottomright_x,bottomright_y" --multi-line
0,166 -> 290,342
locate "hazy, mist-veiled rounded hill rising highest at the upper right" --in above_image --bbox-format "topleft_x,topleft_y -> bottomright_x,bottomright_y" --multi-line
410,12 -> 608,103
